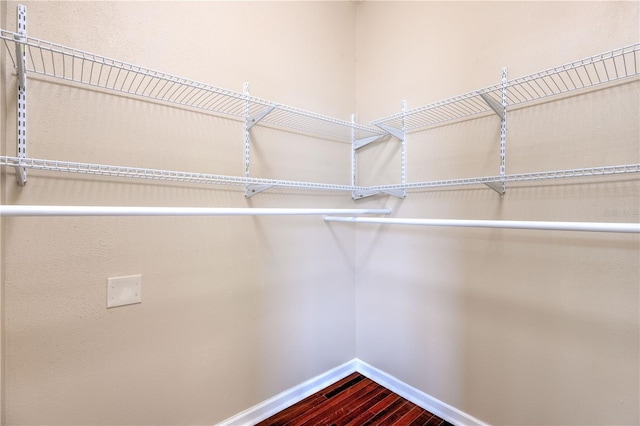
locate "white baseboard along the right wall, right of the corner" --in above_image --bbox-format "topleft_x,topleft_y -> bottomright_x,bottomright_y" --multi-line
355,358 -> 487,426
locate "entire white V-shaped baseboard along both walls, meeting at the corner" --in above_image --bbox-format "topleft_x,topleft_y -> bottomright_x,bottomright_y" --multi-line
218,358 -> 487,426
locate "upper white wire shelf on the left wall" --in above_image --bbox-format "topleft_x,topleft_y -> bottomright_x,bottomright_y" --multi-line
0,30 -> 384,142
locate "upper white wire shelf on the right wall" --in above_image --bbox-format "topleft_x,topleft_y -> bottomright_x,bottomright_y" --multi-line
371,43 -> 640,133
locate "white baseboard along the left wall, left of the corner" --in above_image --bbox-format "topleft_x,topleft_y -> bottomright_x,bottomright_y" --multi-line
218,359 -> 357,426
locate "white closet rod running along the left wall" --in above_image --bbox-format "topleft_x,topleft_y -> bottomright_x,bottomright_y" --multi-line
0,205 -> 391,216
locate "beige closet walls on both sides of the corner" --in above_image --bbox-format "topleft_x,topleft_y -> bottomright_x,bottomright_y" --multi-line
0,2 -> 640,424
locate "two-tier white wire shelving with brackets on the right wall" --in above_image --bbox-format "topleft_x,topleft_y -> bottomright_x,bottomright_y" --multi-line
367,43 -> 640,198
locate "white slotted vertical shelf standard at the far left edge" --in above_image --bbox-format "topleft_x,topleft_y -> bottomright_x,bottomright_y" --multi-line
15,4 -> 27,186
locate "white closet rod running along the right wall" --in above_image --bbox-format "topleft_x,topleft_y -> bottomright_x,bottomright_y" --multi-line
324,216 -> 640,233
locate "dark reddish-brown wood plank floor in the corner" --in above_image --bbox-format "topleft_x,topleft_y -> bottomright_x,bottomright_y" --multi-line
258,373 -> 451,426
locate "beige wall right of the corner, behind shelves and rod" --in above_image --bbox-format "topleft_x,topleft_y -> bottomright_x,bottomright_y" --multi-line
356,2 -> 640,425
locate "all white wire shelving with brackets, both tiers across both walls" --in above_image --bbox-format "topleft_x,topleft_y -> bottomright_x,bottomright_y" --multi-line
0,14 -> 640,198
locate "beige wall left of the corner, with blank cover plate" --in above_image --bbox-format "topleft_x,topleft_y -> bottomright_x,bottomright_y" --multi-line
2,2 -> 355,425
